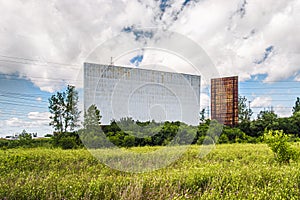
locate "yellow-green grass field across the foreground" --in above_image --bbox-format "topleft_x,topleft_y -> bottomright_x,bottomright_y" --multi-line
0,144 -> 300,199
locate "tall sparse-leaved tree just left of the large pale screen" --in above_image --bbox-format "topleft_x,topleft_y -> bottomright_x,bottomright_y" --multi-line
49,85 -> 80,133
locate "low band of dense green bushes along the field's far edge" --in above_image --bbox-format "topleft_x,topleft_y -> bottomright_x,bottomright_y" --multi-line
0,112 -> 300,149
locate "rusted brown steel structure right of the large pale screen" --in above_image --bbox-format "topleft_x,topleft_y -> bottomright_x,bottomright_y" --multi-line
211,76 -> 238,127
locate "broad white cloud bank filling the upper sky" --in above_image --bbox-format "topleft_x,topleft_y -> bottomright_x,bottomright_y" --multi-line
0,0 -> 300,92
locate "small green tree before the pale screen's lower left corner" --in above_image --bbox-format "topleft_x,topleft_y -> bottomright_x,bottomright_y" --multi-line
83,104 -> 102,129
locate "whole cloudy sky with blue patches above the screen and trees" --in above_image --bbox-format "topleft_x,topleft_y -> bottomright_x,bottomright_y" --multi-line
0,0 -> 300,137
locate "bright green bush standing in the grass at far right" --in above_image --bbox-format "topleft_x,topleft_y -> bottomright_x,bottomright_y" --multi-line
264,131 -> 299,163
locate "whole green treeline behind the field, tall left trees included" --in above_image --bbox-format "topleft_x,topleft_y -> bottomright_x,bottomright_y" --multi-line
0,86 -> 300,149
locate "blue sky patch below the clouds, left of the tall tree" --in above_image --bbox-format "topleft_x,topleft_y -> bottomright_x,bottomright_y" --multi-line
0,75 -> 51,136
